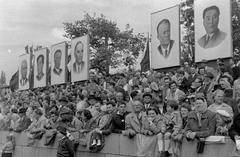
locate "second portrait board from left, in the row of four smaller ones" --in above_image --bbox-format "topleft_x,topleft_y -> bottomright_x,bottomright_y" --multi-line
34,48 -> 48,88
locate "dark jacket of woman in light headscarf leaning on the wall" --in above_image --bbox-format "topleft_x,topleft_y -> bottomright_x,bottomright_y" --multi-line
185,110 -> 216,138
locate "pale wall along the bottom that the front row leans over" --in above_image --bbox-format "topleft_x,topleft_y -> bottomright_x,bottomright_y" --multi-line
0,131 -> 235,157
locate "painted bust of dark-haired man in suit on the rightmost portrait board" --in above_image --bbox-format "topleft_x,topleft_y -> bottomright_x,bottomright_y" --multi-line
198,5 -> 227,49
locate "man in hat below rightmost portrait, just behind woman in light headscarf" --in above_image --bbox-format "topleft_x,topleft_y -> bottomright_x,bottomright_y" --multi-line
203,72 -> 216,103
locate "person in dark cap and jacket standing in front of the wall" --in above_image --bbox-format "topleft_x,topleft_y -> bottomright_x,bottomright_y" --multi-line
57,126 -> 74,157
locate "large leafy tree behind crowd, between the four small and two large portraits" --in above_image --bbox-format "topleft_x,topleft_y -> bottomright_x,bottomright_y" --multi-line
63,14 -> 146,74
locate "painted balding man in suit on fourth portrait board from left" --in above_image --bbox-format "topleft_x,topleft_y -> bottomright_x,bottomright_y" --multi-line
73,41 -> 85,74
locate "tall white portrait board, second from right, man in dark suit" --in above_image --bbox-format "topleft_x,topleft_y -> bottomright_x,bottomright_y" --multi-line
151,5 -> 180,69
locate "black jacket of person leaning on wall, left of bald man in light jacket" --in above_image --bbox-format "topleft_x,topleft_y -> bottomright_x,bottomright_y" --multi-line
111,112 -> 129,133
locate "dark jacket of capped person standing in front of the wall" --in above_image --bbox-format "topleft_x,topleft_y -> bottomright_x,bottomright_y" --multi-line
57,136 -> 74,157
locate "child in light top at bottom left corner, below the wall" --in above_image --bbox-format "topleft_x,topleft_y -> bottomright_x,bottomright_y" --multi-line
0,134 -> 15,157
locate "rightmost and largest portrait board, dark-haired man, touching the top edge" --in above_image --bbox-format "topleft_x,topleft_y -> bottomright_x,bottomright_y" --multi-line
194,0 -> 232,62
